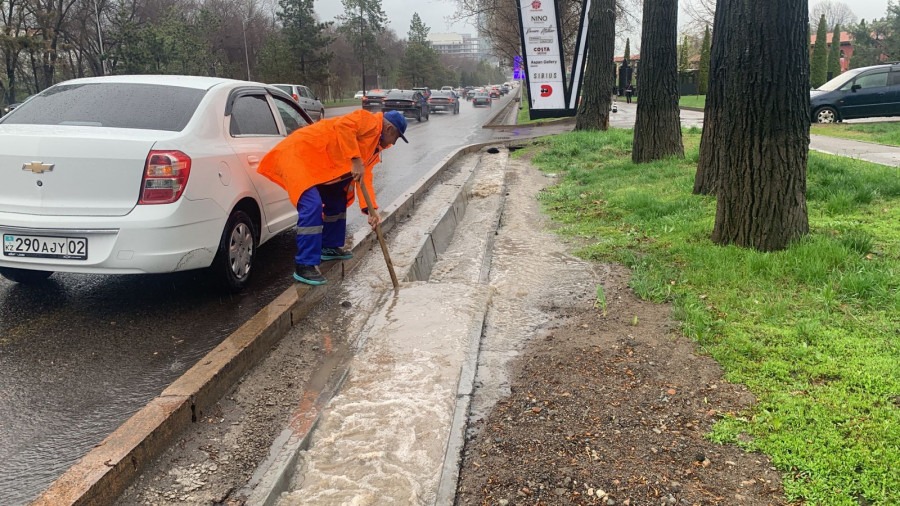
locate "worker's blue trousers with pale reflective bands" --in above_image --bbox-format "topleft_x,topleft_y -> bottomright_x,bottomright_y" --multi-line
294,179 -> 353,265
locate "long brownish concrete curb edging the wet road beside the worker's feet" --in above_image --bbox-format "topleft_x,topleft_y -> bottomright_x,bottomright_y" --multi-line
32,141 -> 522,506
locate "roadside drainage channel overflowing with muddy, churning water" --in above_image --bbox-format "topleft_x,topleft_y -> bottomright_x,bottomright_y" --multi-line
241,149 -> 507,505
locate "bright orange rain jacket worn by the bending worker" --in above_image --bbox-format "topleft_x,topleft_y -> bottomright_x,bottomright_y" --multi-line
256,109 -> 384,209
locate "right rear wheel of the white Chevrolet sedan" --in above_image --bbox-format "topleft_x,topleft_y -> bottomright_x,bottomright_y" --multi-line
211,209 -> 257,292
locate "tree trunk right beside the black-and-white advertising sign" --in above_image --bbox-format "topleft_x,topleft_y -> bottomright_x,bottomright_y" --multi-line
572,0 -> 616,130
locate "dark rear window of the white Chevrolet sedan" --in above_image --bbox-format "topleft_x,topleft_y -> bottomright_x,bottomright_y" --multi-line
2,83 -> 206,132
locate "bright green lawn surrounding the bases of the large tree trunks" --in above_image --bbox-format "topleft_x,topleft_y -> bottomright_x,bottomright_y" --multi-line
533,129 -> 900,505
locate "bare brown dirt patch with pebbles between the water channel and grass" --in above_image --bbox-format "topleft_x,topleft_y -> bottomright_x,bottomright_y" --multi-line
457,266 -> 785,505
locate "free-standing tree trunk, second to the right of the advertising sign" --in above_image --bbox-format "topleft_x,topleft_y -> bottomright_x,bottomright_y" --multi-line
631,0 -> 684,163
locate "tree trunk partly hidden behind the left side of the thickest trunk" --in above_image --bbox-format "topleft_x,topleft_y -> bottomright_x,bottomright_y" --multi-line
694,9 -> 729,195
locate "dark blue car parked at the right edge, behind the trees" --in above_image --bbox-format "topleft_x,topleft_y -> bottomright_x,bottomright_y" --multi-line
809,63 -> 900,123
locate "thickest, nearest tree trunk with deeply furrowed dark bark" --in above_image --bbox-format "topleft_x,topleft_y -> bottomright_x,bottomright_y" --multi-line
712,0 -> 809,251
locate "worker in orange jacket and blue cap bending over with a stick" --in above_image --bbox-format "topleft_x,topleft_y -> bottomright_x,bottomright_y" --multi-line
257,110 -> 409,285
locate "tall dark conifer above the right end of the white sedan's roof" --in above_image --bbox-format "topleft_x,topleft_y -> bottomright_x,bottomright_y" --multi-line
277,0 -> 334,87
